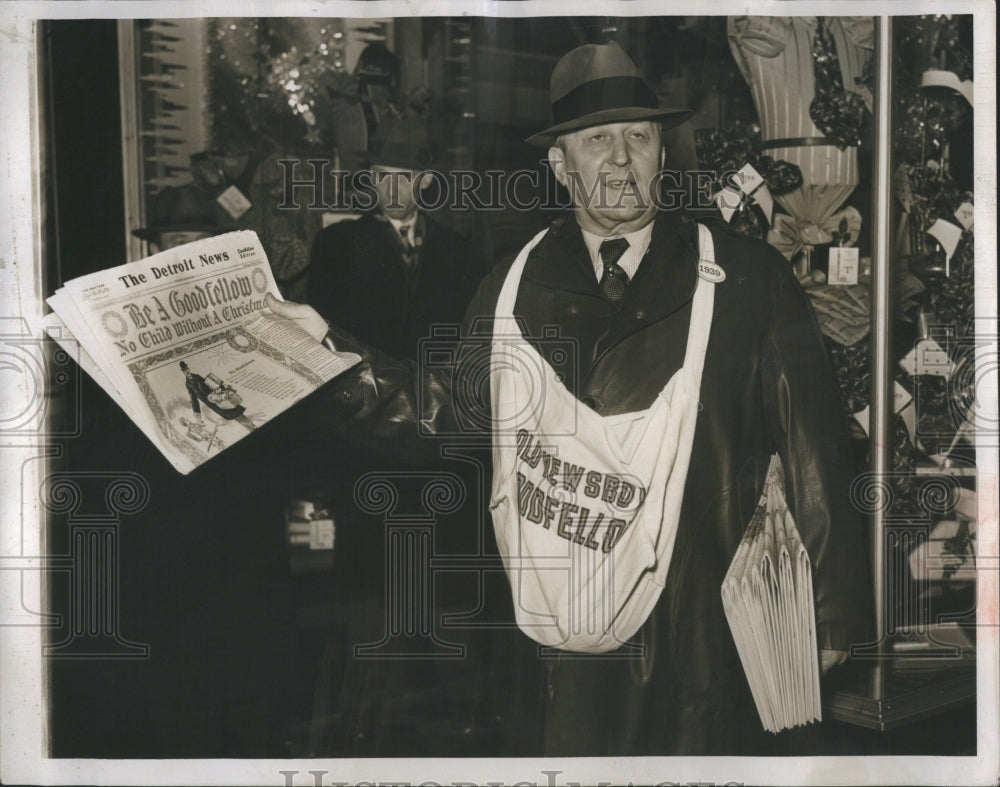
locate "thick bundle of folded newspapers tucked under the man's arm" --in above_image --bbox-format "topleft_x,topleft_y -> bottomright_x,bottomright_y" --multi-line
722,455 -> 822,732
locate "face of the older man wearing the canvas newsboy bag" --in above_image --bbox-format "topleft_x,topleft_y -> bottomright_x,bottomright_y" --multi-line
549,121 -> 663,235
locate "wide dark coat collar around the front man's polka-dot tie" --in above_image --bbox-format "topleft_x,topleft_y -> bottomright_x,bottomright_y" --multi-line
523,211 -> 698,319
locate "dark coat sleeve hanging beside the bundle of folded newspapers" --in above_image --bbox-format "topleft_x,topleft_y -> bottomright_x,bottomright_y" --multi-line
762,260 -> 874,650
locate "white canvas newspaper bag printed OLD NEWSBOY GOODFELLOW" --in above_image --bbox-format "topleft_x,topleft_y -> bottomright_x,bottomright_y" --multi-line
490,225 -> 724,653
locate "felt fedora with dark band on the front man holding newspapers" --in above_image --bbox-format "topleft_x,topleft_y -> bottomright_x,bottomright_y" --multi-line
526,42 -> 691,146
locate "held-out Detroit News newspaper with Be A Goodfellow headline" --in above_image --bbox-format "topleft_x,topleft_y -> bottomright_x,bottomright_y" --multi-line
45,232 -> 361,473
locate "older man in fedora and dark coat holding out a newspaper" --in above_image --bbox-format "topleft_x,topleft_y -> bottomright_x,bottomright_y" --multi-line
271,44 -> 872,756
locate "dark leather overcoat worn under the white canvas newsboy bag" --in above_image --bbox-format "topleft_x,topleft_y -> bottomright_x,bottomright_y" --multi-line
310,213 -> 872,756
